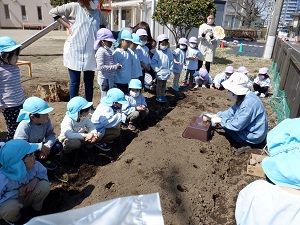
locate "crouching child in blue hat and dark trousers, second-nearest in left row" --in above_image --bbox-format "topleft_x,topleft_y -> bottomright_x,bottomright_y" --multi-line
14,96 -> 62,170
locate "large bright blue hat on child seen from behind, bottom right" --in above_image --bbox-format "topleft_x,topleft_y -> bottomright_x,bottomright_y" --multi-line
262,118 -> 300,189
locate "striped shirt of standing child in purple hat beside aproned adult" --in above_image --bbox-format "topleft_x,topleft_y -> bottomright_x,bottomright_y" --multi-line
95,47 -> 118,79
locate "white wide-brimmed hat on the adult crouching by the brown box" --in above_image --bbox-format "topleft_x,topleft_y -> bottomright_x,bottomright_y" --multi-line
222,72 -> 249,95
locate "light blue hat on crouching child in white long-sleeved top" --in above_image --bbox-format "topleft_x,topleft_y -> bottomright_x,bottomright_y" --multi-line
66,96 -> 93,121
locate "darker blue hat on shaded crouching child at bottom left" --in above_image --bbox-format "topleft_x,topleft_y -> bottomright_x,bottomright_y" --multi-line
0,139 -> 38,180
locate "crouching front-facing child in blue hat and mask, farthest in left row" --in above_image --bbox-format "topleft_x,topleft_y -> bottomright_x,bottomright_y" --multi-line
122,79 -> 149,131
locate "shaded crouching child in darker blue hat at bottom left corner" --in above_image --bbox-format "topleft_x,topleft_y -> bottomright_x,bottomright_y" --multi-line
0,140 -> 50,224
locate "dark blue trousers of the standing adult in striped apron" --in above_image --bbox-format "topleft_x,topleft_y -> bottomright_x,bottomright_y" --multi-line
68,69 -> 95,102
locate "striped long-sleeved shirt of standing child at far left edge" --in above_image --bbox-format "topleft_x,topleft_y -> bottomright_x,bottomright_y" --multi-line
0,64 -> 25,108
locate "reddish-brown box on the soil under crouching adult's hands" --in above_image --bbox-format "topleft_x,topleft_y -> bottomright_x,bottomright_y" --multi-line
182,116 -> 213,141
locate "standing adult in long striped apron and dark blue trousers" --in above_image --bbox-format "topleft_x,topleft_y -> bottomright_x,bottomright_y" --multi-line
50,0 -> 107,102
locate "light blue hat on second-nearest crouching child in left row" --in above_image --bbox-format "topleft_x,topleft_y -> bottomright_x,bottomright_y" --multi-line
17,96 -> 53,122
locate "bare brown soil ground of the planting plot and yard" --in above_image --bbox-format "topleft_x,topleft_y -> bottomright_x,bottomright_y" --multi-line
0,30 -> 276,225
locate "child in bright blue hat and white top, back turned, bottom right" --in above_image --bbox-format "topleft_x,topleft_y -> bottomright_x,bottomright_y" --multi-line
235,118 -> 300,225
